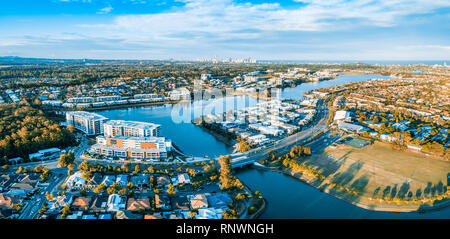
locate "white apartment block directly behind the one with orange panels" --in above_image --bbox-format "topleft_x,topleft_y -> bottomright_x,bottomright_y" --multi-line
104,120 -> 161,137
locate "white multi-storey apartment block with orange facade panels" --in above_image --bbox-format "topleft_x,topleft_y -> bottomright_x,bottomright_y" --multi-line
91,136 -> 172,161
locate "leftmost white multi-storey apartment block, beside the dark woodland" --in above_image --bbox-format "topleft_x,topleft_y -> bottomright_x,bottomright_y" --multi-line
66,111 -> 108,135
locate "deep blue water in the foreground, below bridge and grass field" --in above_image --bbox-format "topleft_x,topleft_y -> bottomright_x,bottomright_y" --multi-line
237,168 -> 450,219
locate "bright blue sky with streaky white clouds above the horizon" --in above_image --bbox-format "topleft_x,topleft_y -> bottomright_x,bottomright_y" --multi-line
0,0 -> 450,60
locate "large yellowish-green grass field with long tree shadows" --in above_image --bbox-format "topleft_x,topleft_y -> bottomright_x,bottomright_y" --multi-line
302,142 -> 450,204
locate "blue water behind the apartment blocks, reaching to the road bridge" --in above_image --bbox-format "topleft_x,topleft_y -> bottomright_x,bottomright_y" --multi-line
97,96 -> 257,157
